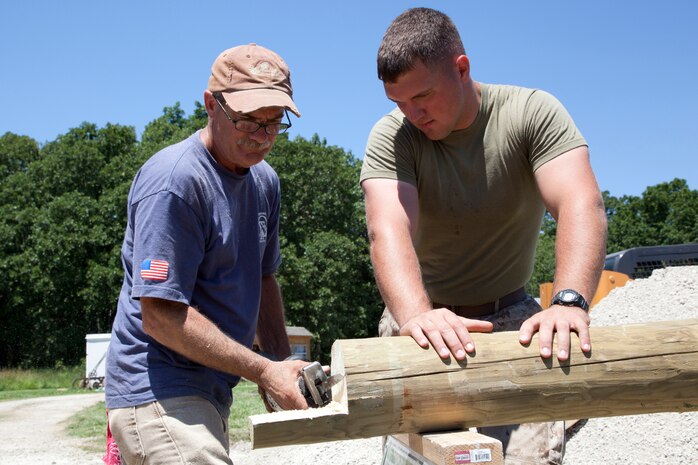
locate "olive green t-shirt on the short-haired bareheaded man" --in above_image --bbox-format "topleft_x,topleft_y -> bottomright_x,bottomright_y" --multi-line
361,84 -> 586,305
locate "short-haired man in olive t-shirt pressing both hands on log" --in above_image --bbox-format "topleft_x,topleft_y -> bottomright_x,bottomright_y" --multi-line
361,8 -> 606,464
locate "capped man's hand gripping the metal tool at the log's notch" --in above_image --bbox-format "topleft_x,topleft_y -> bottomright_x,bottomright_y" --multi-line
259,360 -> 310,412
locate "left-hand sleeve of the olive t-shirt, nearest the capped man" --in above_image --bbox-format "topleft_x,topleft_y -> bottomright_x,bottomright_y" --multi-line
360,112 -> 417,185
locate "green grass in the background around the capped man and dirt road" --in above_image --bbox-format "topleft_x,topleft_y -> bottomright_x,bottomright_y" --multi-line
0,367 -> 266,452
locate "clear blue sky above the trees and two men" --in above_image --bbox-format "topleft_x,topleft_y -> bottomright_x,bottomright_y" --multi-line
0,0 -> 698,196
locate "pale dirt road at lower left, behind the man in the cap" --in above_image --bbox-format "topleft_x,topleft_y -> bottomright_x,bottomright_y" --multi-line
0,393 -> 104,465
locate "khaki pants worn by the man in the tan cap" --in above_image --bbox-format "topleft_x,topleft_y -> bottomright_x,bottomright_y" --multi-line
109,396 -> 233,465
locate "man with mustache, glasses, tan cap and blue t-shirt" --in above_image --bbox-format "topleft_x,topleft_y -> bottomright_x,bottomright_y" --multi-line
106,44 -> 307,464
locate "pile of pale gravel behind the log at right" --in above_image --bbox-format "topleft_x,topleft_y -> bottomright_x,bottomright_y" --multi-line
564,266 -> 698,465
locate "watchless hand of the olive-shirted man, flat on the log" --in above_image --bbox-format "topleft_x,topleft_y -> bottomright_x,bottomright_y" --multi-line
400,308 -> 492,360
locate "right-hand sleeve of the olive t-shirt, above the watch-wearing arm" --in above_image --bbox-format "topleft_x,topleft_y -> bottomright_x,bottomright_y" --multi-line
524,90 -> 587,171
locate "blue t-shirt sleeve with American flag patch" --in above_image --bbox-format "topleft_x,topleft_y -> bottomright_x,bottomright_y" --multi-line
131,191 -> 205,305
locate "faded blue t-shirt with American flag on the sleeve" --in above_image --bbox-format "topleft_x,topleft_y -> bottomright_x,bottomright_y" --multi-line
105,132 -> 281,418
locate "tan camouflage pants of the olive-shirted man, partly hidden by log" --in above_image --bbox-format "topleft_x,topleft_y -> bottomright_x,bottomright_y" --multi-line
378,297 -> 565,465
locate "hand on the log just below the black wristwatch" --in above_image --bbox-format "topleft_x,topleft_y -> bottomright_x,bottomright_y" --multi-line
519,305 -> 591,361
